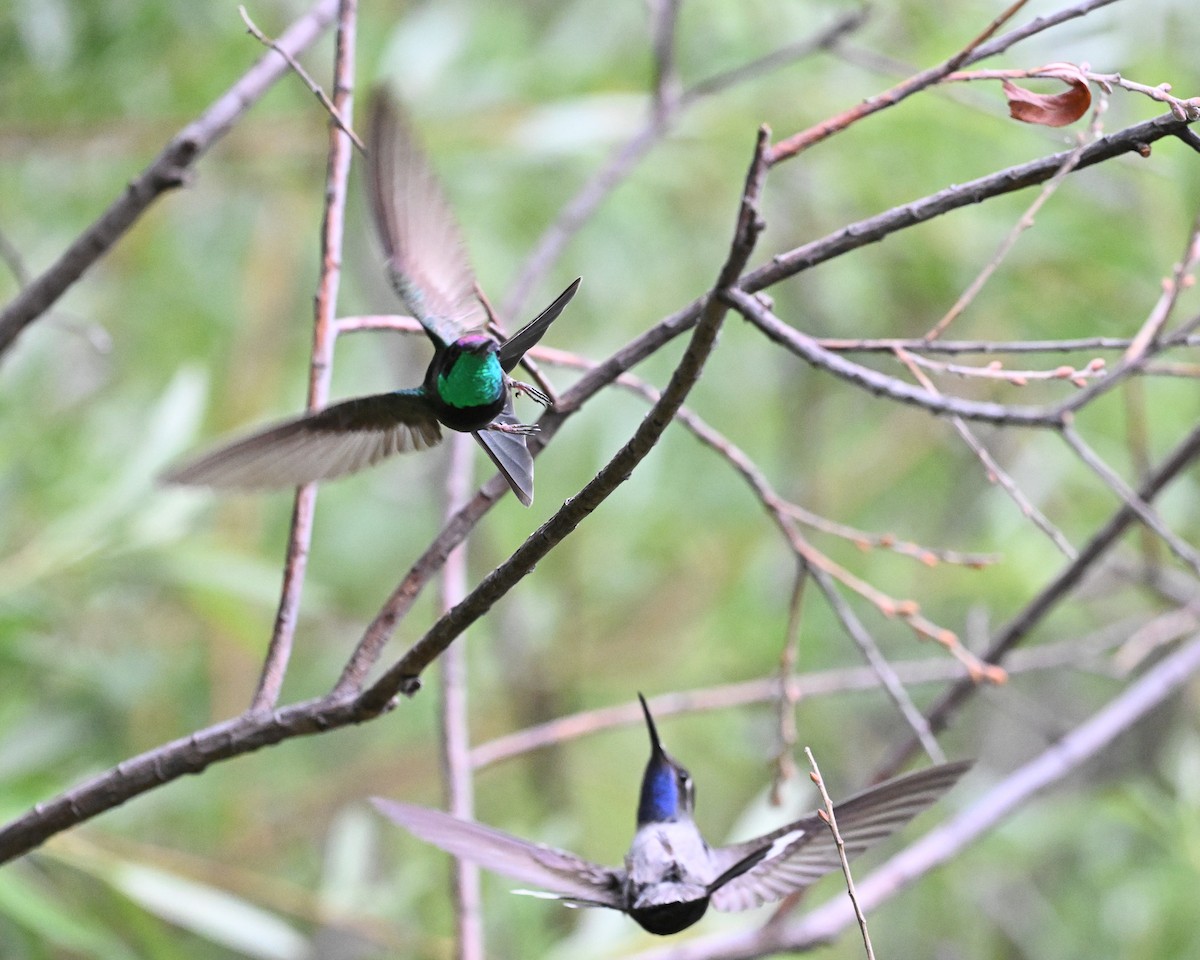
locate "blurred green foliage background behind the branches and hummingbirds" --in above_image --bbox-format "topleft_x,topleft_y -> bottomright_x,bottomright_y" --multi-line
0,0 -> 1200,960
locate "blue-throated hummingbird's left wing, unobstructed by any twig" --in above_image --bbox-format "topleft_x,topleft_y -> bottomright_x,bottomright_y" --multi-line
371,797 -> 625,910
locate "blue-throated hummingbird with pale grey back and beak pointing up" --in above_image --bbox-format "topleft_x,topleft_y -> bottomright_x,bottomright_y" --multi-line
372,694 -> 971,936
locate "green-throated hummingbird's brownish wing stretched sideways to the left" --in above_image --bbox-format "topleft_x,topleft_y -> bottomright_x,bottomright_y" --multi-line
162,390 -> 442,490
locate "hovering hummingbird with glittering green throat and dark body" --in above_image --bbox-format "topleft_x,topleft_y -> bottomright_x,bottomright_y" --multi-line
163,94 -> 580,506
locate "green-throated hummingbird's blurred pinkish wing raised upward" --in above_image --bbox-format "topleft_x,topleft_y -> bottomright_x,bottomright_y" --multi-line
366,91 -> 486,347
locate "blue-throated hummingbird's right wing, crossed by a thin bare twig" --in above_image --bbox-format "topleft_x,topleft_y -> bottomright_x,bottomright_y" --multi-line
712,761 -> 971,912
